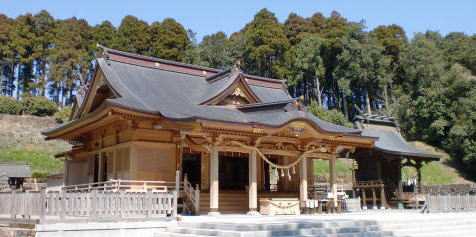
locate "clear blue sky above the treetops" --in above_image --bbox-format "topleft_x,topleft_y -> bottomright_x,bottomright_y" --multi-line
0,0 -> 476,39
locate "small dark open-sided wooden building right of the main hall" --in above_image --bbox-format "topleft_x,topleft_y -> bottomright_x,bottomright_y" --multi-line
352,114 -> 439,207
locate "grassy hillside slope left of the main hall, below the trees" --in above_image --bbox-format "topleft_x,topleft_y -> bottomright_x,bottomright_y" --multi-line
0,114 -> 69,176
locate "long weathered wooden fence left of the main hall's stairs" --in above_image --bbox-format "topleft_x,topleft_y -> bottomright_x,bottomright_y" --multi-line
0,190 -> 177,221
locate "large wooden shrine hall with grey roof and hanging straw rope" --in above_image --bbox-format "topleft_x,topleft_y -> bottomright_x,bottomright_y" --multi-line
44,47 -> 376,214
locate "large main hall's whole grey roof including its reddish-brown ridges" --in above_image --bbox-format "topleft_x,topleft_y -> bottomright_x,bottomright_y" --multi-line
44,48 -> 360,136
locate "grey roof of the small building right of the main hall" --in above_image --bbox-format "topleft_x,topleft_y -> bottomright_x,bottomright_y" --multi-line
362,128 -> 439,159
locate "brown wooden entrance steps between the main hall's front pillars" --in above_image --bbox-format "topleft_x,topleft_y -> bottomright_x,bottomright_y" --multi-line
200,190 -> 299,214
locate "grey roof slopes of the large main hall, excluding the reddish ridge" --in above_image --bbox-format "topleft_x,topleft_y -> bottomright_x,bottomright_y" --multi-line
98,54 -> 360,133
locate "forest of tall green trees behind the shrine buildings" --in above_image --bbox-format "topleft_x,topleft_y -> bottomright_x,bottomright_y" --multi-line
0,9 -> 476,176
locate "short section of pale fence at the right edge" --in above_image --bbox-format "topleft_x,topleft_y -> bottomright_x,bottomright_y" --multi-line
425,194 -> 476,212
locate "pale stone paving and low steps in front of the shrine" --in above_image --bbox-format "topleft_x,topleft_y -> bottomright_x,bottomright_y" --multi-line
155,210 -> 476,237
